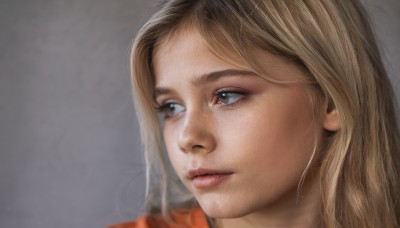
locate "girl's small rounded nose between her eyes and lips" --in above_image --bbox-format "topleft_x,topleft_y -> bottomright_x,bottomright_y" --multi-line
178,112 -> 216,153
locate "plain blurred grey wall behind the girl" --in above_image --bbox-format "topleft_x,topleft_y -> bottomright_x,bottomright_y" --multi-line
0,0 -> 400,228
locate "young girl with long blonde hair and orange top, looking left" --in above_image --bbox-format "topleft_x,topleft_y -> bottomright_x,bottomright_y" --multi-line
111,0 -> 400,228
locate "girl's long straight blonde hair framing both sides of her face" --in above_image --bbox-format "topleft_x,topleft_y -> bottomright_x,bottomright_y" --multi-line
131,0 -> 400,228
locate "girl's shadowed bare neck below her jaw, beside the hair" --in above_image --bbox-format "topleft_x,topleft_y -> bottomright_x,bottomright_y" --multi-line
216,174 -> 321,228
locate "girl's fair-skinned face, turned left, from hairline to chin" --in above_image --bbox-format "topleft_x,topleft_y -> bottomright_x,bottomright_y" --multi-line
154,30 -> 330,221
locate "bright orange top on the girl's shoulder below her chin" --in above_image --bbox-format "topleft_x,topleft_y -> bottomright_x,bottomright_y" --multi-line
109,208 -> 210,228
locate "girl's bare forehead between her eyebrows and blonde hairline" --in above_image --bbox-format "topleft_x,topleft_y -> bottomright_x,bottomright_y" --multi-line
153,28 -> 309,85
